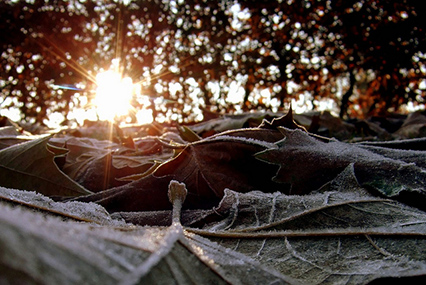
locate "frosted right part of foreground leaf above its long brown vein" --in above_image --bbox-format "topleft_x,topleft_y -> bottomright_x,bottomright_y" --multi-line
198,165 -> 426,233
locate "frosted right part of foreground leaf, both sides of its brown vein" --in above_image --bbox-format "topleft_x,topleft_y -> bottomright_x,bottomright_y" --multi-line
190,166 -> 426,284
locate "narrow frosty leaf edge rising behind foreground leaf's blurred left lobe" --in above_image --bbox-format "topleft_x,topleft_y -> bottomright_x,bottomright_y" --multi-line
0,187 -> 125,226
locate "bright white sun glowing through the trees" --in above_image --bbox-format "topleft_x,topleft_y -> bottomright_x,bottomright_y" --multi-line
93,70 -> 135,121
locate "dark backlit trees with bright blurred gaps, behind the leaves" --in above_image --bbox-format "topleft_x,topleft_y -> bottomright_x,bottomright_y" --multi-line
0,0 -> 426,125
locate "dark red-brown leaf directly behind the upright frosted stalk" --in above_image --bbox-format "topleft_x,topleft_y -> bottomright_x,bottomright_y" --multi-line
154,130 -> 279,202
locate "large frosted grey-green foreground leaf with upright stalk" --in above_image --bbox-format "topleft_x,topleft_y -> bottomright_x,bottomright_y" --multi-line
0,171 -> 426,284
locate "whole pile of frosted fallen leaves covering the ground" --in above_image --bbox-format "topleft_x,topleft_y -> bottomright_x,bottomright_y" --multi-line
0,112 -> 426,284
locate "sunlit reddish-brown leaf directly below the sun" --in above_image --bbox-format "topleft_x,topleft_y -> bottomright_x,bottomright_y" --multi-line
49,136 -> 172,192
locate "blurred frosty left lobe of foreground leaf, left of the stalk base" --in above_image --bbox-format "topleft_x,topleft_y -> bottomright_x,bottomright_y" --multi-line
0,199 -> 176,284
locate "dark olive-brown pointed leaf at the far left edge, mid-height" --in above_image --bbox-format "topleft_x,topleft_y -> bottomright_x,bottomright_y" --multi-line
0,136 -> 91,196
